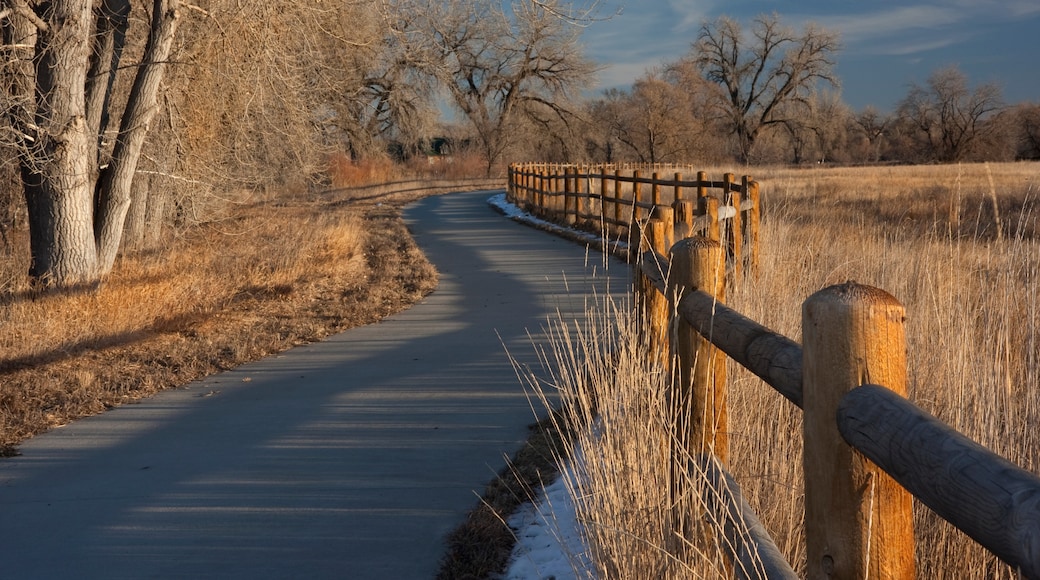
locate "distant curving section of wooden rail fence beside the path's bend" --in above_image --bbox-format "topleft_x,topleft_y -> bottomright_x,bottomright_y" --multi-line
508,163 -> 761,276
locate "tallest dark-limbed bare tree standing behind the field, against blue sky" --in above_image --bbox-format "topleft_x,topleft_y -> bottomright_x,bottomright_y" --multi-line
687,15 -> 840,162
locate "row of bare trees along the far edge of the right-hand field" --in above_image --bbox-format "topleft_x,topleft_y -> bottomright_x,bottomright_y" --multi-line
582,15 -> 1040,168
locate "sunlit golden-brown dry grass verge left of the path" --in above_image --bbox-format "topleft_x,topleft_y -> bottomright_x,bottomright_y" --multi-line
0,161 -> 505,454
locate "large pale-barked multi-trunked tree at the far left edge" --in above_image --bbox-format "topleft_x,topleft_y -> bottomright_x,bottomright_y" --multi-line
0,0 -> 180,286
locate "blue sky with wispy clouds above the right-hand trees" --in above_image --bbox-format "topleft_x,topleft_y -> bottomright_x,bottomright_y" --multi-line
581,0 -> 1040,111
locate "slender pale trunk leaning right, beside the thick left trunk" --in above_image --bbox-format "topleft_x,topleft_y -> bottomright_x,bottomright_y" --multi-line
95,0 -> 180,273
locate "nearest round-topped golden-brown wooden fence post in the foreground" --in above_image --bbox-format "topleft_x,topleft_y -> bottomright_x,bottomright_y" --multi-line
802,283 -> 914,579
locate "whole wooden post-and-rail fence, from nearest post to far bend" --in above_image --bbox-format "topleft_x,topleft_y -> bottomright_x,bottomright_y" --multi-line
510,165 -> 1040,579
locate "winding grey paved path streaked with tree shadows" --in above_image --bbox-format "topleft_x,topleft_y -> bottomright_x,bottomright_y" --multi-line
0,192 -> 626,579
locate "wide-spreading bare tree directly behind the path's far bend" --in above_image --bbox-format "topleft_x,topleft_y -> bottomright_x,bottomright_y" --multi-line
388,0 -> 593,175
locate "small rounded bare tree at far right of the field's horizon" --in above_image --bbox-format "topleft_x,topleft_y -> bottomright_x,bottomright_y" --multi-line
898,67 -> 1003,162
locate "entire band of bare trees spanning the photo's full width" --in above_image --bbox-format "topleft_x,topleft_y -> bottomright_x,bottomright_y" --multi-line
0,0 -> 1040,286
